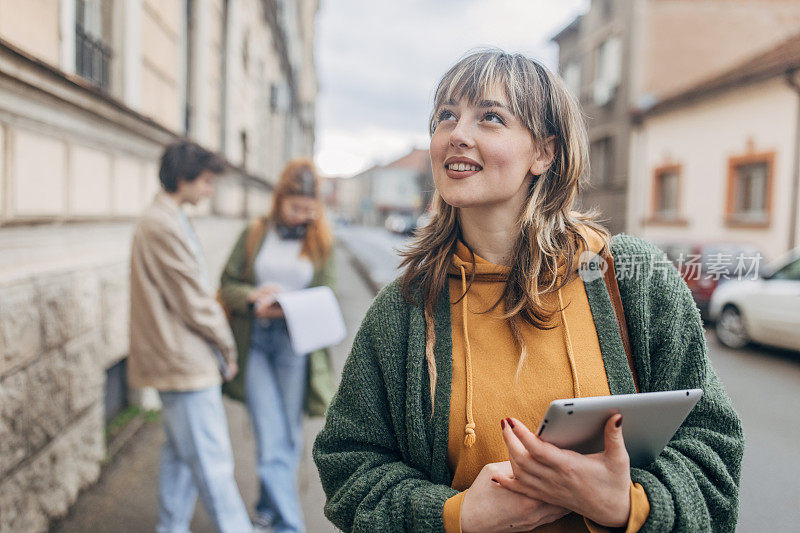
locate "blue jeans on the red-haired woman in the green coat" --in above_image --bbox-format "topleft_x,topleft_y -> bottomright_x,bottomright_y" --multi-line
245,319 -> 308,533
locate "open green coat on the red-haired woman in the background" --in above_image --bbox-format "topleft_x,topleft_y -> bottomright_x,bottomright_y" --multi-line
220,220 -> 334,416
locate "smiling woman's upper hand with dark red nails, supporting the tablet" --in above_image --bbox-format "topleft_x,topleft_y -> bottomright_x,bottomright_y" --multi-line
496,414 -> 631,527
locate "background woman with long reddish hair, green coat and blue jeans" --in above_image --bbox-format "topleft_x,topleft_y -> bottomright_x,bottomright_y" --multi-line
220,159 -> 333,532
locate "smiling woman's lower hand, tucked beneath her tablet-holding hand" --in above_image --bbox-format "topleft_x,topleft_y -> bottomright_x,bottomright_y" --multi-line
461,461 -> 570,533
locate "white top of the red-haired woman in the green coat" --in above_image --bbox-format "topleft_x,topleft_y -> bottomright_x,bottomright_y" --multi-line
253,228 -> 314,291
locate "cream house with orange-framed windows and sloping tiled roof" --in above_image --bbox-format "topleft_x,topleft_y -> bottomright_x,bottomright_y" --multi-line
628,35 -> 800,258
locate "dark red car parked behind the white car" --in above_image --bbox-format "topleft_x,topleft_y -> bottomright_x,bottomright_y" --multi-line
657,242 -> 763,320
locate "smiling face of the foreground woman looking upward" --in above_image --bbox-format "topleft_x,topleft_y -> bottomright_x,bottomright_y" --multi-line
430,84 -> 540,208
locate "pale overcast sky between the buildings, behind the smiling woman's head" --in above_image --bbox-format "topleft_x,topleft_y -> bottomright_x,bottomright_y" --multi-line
315,0 -> 589,176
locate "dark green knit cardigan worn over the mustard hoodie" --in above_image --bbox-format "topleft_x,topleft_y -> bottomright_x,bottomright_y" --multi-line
313,235 -> 744,532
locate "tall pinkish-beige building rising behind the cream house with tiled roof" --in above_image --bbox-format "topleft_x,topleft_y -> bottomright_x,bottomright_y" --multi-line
553,0 -> 800,233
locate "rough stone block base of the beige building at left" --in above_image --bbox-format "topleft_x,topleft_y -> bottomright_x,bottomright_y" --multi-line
0,264 -> 119,531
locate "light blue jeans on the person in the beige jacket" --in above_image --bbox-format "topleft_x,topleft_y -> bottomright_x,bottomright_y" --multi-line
156,386 -> 253,533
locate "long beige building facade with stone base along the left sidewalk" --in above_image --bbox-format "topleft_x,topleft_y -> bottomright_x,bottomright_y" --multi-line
0,0 -> 318,533
